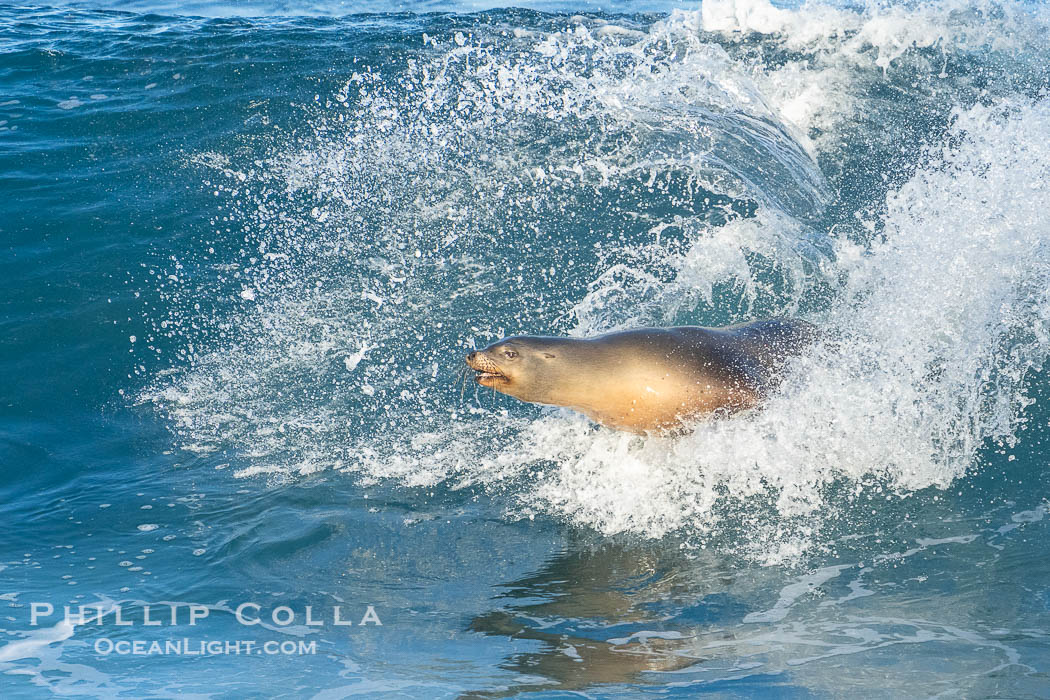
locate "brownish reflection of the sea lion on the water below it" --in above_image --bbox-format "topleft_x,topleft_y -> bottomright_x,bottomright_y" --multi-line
464,540 -> 748,698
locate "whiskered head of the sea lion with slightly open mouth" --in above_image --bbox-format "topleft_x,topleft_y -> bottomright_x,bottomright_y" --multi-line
466,336 -> 567,404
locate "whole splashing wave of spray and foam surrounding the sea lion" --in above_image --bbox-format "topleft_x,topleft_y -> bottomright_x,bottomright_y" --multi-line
131,2 -> 1050,560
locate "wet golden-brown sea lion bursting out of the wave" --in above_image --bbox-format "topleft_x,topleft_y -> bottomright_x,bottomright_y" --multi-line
466,319 -> 817,433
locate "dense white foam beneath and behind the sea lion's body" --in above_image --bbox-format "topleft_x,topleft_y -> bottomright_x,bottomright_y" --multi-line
516,102 -> 1050,548
